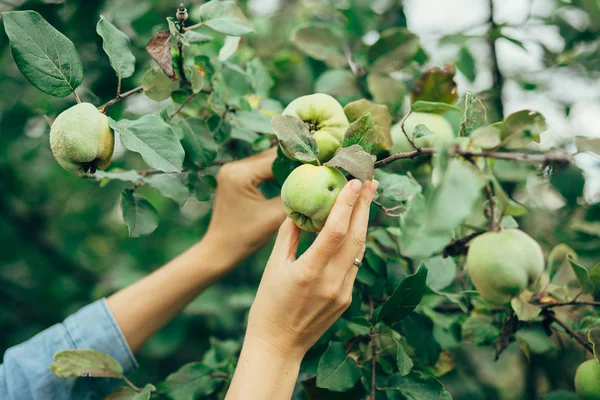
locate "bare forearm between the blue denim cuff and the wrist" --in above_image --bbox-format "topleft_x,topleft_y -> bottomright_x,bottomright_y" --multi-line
107,235 -> 239,352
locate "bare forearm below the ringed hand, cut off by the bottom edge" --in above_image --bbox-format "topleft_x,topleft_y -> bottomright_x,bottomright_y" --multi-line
225,336 -> 302,400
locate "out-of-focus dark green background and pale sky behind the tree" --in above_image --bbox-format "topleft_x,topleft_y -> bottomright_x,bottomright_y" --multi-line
0,0 -> 600,399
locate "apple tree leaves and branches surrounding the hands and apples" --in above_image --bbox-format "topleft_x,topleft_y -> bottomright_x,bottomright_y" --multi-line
0,0 -> 600,400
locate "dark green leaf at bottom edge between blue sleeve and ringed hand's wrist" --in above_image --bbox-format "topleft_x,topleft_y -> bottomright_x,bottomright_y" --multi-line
158,362 -> 226,400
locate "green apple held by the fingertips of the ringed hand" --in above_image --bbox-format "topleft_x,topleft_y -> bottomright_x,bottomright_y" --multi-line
281,164 -> 348,232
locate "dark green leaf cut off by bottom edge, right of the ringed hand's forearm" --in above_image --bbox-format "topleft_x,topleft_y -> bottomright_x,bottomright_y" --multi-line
386,371 -> 444,400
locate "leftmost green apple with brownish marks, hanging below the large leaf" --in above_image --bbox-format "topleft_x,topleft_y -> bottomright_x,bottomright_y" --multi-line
50,103 -> 115,173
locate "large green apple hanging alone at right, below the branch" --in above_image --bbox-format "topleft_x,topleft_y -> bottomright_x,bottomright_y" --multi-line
466,229 -> 544,305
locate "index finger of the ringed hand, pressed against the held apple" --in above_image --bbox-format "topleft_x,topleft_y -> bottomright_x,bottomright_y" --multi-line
302,179 -> 363,268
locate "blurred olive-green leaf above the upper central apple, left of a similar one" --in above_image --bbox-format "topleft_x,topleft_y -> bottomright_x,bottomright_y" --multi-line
290,23 -> 348,67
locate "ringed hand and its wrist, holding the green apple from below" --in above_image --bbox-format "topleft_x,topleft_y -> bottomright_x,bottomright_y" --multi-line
227,180 -> 378,400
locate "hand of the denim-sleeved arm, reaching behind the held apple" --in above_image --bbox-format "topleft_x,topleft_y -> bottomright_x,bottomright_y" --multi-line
203,148 -> 285,266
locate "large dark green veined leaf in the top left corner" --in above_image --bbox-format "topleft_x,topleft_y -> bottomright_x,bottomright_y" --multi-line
2,11 -> 83,97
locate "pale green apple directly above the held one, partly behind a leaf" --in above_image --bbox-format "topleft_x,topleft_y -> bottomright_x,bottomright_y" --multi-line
282,93 -> 350,163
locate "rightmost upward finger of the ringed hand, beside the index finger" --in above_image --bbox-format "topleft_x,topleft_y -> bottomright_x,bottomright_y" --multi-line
331,181 -> 379,273
